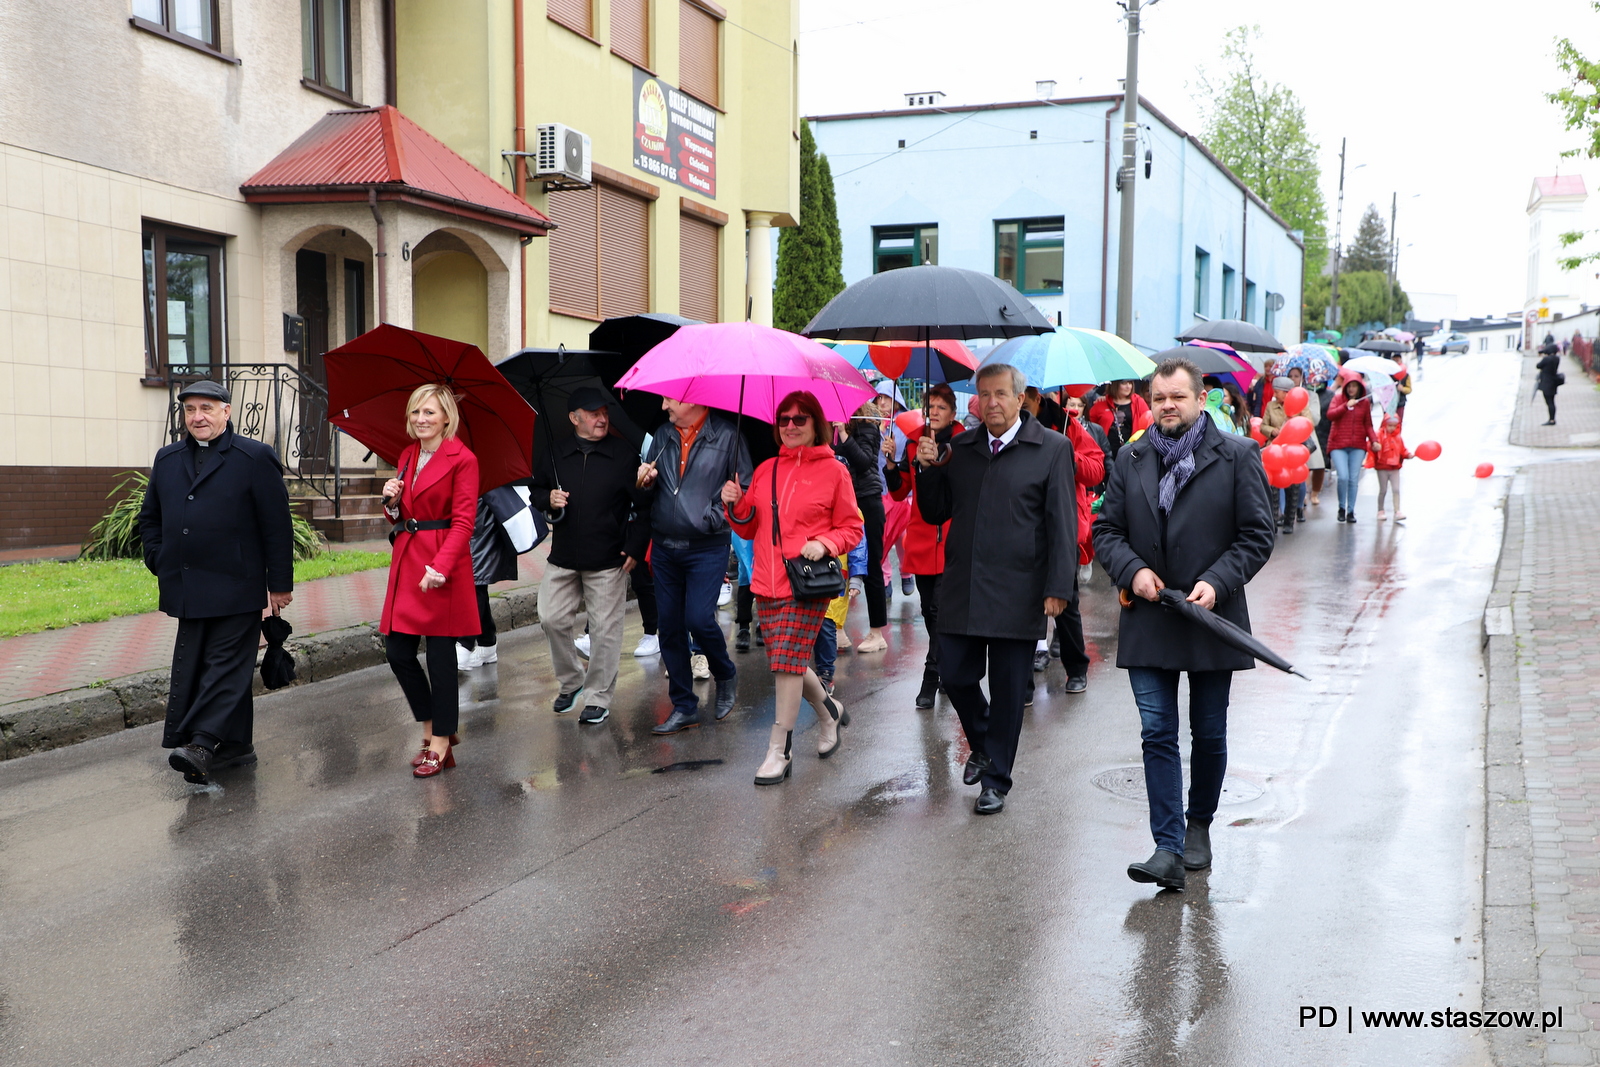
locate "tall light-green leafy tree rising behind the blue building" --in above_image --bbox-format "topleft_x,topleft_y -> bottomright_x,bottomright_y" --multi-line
1195,26 -> 1328,278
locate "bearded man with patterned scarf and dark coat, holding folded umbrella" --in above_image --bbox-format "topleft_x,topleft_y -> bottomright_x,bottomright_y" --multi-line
1094,360 -> 1274,889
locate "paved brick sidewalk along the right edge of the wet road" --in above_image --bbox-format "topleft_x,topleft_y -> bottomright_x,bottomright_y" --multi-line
1485,460 -> 1600,1064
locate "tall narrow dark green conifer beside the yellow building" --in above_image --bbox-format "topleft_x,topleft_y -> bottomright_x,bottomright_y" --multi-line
773,120 -> 845,333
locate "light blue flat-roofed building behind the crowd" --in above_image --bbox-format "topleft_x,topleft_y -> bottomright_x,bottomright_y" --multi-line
811,94 -> 1304,352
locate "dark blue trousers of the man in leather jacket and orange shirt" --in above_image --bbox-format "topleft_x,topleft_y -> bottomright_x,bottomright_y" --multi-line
650,541 -> 736,715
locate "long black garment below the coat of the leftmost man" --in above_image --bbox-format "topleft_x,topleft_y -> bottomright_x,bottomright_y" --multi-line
162,611 -> 261,749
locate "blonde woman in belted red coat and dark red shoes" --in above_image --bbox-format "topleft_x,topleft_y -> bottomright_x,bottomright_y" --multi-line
378,386 -> 482,777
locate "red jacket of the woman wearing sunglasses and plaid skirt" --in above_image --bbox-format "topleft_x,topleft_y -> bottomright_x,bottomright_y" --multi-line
726,445 -> 862,600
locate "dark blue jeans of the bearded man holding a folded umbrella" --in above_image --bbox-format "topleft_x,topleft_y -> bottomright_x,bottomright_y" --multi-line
1128,667 -> 1234,856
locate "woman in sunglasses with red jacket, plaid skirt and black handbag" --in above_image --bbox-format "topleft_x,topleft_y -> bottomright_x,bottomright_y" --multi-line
722,392 -> 862,785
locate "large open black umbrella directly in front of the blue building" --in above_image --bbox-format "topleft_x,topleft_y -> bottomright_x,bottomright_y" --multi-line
800,266 -> 1054,341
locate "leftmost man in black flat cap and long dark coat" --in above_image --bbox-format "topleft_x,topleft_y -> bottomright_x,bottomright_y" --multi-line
139,381 -> 294,782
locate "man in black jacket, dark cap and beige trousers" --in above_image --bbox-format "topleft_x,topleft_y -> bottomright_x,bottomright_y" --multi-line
530,386 -> 650,726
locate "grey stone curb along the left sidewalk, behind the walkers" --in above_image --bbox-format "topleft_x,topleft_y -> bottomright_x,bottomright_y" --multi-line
0,584 -> 560,760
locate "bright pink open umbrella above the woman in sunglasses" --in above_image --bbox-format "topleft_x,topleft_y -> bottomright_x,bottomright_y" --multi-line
616,322 -> 877,422
